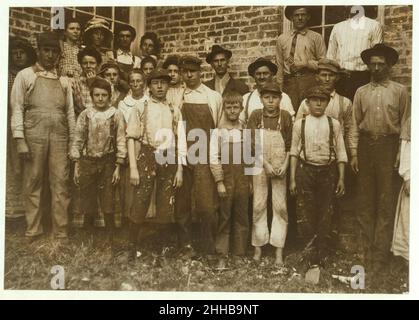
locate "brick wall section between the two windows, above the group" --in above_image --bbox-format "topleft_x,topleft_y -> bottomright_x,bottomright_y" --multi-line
146,6 -> 283,89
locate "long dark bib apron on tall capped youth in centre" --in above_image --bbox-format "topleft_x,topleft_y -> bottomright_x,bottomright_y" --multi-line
179,103 -> 218,253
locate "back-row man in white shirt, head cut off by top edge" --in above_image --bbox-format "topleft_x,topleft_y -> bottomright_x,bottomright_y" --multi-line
327,6 -> 383,100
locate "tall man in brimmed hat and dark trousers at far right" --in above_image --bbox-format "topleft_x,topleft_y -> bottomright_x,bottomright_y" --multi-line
349,44 -> 410,272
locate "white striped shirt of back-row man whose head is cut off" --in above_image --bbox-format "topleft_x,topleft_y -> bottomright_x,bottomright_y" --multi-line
327,16 -> 383,71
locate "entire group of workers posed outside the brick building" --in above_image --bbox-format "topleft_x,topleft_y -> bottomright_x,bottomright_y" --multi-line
7,6 -> 410,278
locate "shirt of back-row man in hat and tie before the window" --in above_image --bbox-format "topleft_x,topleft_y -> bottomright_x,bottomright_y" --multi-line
276,29 -> 326,84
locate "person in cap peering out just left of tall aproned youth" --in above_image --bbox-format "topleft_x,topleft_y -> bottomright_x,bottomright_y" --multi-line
162,55 -> 185,110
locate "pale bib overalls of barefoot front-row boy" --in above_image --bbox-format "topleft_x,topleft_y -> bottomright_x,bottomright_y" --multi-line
252,120 -> 288,248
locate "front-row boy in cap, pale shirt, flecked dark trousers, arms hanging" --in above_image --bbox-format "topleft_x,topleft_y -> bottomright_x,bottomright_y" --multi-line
127,69 -> 186,261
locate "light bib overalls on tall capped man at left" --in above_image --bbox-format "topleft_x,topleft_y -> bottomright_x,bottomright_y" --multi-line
24,76 -> 70,237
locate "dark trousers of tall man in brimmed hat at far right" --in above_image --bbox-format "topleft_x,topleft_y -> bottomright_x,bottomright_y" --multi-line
357,134 -> 401,263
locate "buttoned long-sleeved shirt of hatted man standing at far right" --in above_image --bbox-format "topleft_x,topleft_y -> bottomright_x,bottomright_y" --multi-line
349,80 -> 410,156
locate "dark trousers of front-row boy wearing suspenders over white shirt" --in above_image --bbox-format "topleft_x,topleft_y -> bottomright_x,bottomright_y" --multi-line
295,161 -> 337,264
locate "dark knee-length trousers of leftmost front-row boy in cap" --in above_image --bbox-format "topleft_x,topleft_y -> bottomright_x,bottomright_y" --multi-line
80,155 -> 115,229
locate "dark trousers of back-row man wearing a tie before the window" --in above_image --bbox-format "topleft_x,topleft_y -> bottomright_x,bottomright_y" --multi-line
283,72 -> 316,112
